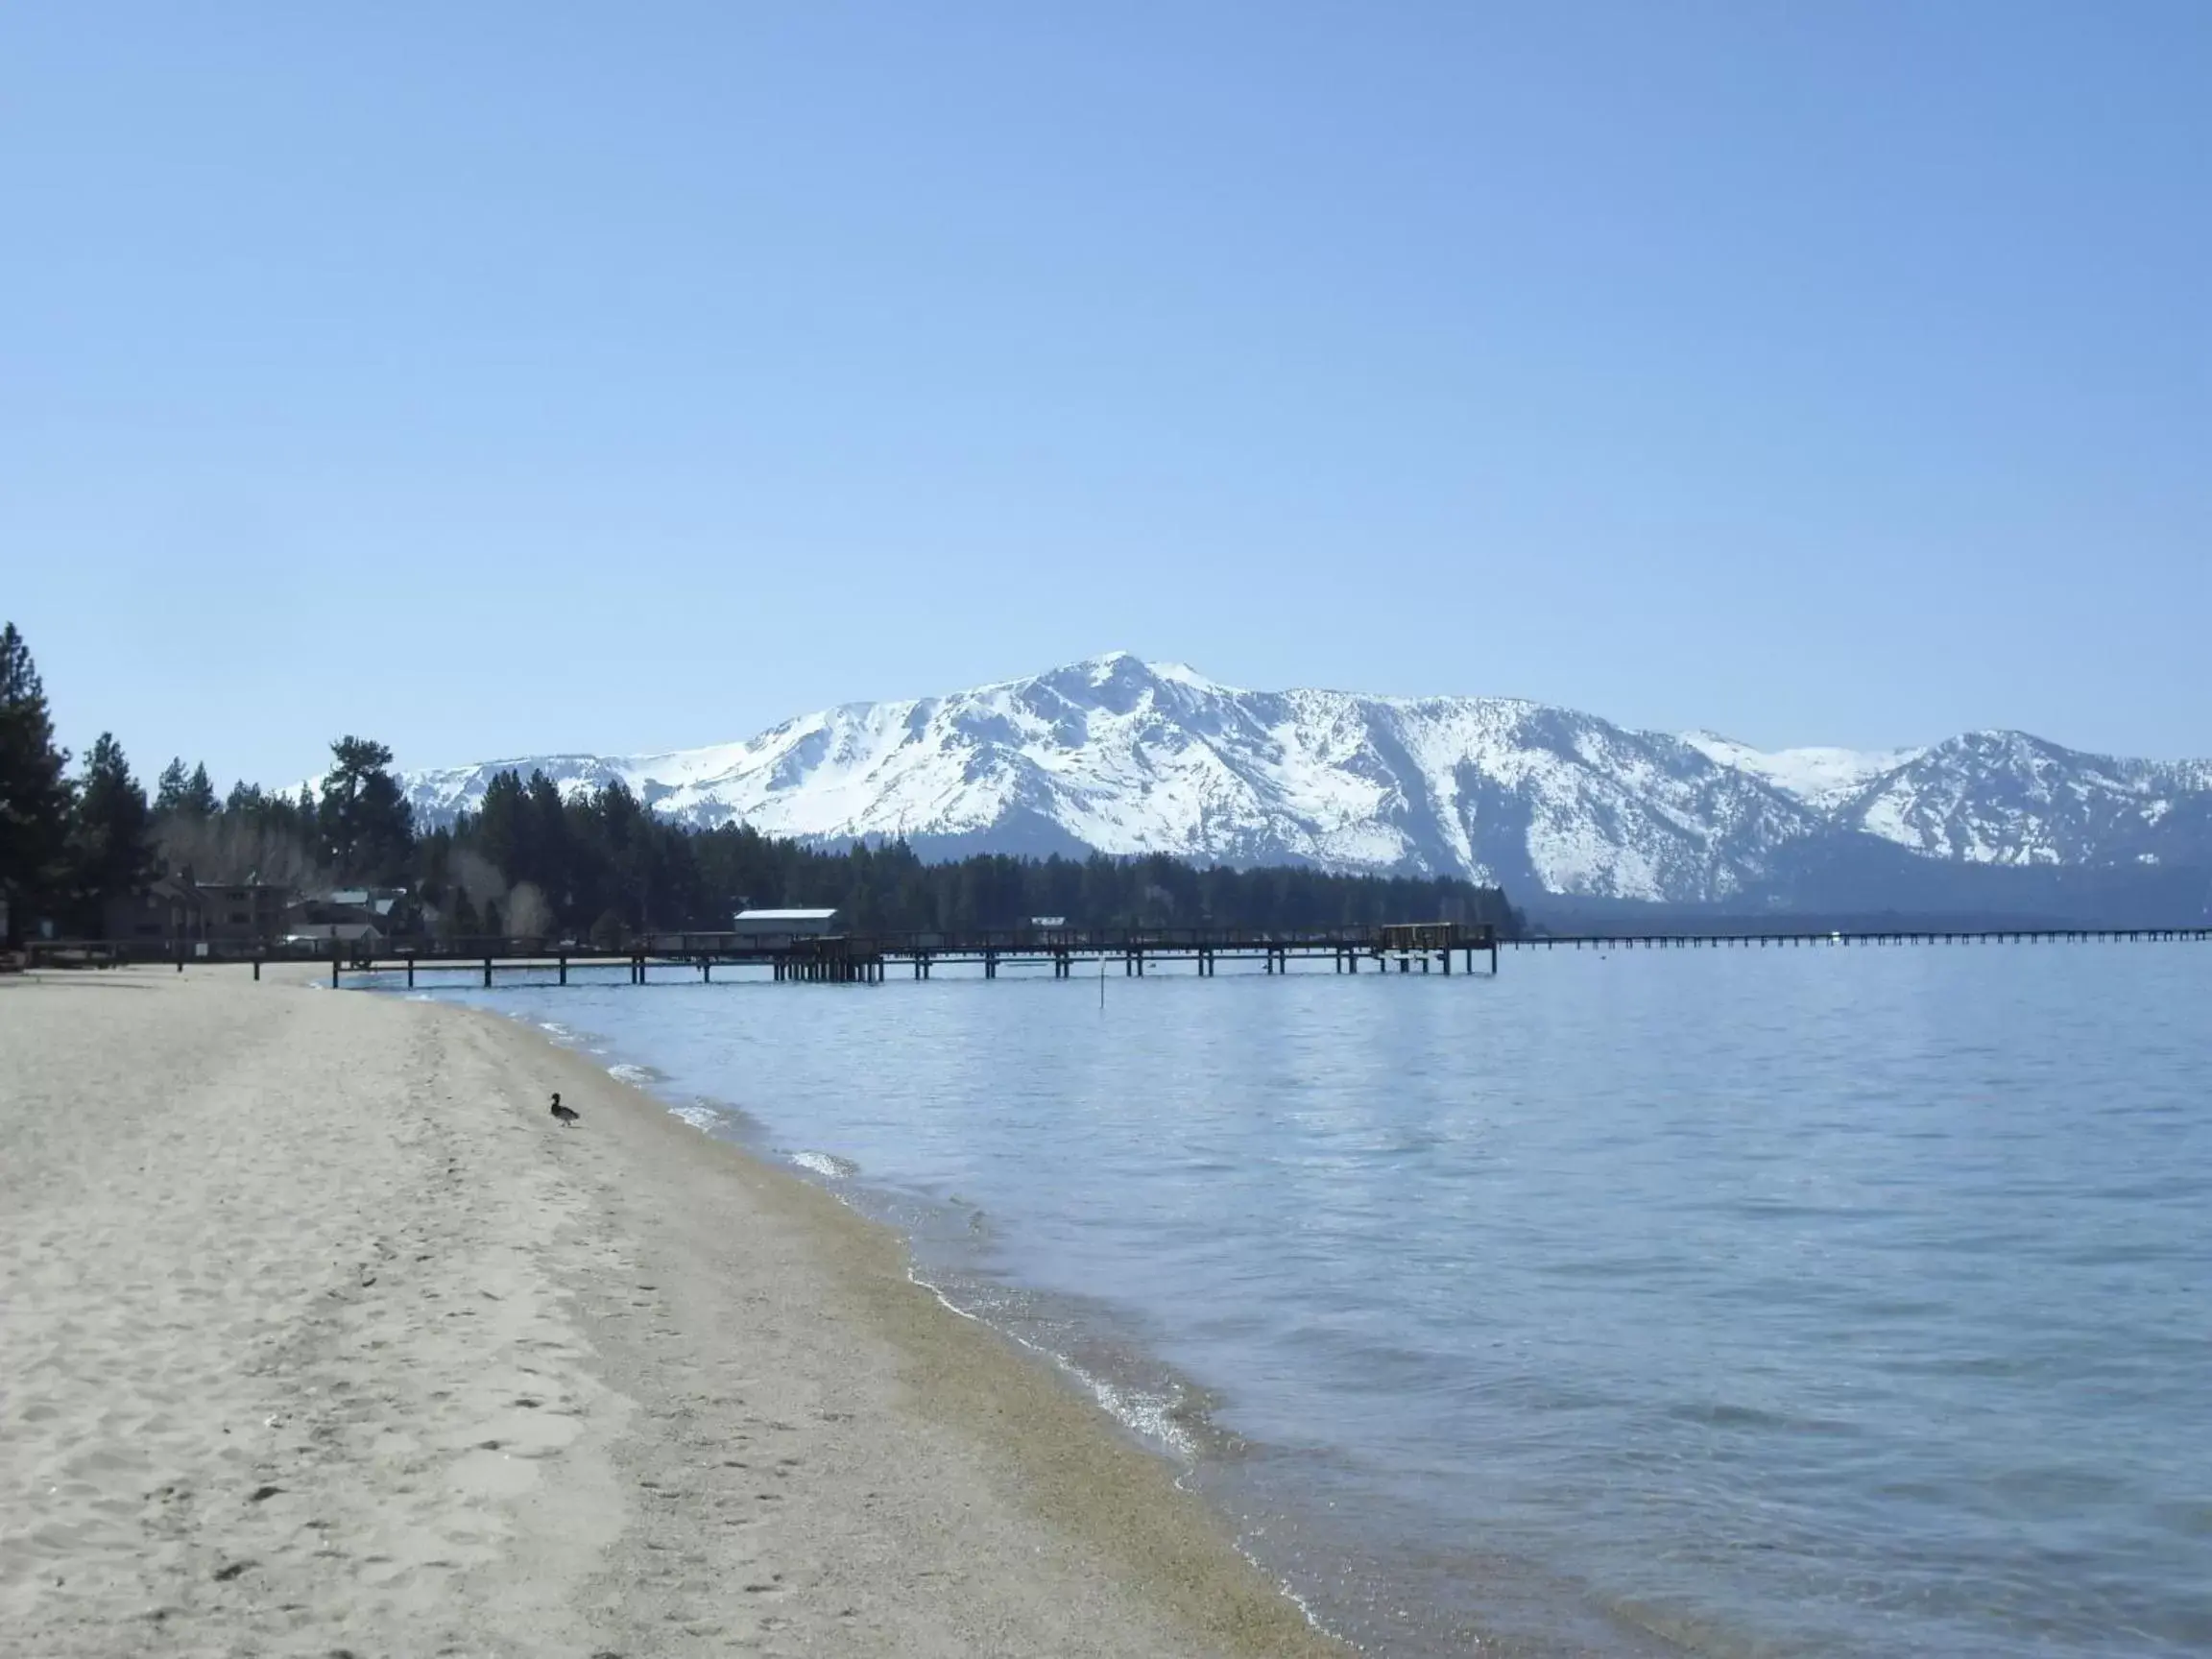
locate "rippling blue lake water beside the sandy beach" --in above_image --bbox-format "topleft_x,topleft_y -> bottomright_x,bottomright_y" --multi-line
406,945 -> 2212,1657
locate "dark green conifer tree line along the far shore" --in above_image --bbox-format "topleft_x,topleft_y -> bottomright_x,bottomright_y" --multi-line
0,624 -> 1520,949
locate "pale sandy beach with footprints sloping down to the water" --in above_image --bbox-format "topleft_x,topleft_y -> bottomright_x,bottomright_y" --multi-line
0,969 -> 1338,1659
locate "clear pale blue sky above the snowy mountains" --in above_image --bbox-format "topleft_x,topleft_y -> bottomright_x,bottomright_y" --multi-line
0,0 -> 2212,783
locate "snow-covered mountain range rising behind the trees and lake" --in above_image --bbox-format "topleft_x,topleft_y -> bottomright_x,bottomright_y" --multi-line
405,653 -> 2212,902
